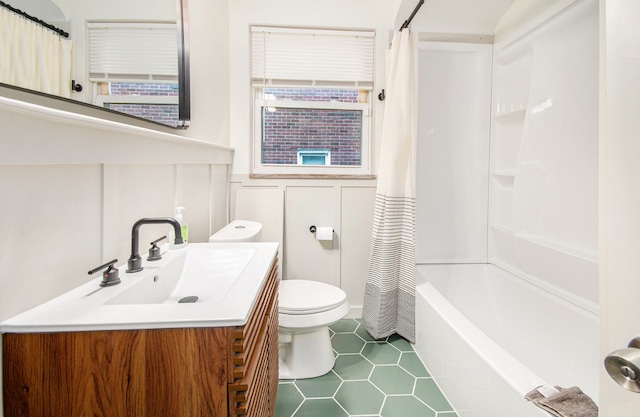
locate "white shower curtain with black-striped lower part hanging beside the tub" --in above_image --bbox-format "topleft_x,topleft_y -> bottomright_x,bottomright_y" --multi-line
363,29 -> 418,342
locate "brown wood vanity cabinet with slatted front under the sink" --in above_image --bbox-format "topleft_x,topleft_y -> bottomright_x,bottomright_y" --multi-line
3,259 -> 279,417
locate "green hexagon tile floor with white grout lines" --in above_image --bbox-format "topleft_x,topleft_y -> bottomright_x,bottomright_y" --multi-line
275,319 -> 457,417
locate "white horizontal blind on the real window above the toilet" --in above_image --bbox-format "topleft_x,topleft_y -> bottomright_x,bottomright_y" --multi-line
251,26 -> 374,89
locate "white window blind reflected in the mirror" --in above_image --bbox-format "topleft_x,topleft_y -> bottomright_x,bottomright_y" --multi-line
87,23 -> 178,82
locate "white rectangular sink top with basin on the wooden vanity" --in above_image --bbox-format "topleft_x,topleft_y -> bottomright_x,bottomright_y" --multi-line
0,242 -> 278,333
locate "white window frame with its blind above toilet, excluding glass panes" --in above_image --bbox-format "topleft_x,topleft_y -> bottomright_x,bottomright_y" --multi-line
250,25 -> 376,179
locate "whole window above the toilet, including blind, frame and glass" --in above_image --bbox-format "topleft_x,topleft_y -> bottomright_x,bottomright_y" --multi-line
252,27 -> 373,175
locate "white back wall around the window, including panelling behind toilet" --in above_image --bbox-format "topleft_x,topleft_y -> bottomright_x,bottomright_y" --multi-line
229,0 -> 393,316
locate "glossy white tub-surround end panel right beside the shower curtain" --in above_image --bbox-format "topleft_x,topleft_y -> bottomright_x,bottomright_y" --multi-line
416,42 -> 493,263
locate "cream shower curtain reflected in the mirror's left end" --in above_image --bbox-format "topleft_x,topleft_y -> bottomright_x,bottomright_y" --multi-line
0,7 -> 71,98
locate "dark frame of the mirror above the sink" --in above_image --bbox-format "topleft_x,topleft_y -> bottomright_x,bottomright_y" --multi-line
0,0 -> 191,130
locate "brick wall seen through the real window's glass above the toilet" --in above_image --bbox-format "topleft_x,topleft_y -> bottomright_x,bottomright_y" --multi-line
262,88 -> 362,166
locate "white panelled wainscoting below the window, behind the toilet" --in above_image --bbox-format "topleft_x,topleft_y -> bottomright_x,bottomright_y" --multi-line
231,177 -> 375,317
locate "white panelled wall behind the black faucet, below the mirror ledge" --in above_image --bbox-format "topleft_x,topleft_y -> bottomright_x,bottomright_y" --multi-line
0,160 -> 225,320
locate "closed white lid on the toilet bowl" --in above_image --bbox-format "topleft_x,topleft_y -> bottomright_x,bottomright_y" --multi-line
279,279 -> 347,314
